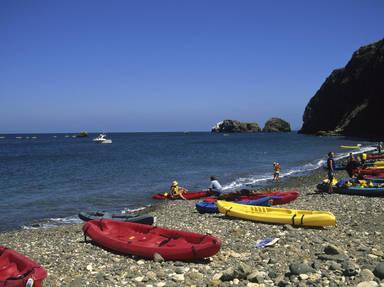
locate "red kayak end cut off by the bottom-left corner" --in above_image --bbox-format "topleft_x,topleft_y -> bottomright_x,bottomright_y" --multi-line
0,246 -> 47,287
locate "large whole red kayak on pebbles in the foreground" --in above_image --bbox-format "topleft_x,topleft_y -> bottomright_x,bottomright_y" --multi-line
83,219 -> 221,261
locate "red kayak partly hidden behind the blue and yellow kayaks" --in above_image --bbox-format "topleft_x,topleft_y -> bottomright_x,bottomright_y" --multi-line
204,190 -> 299,205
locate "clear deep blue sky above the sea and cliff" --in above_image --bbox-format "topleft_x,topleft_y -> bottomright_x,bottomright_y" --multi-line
0,0 -> 384,133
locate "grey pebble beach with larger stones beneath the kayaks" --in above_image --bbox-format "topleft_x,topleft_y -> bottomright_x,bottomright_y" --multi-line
0,170 -> 384,287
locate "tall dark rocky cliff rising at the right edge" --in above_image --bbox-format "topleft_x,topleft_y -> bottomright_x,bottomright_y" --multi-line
300,40 -> 384,137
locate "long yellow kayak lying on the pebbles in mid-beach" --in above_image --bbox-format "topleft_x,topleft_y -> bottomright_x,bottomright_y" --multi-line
216,200 -> 336,227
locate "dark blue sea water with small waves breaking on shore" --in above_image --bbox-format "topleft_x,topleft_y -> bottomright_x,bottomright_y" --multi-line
0,132 -> 368,231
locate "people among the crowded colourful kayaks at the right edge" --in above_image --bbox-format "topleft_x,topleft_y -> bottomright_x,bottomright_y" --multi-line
317,143 -> 384,196
